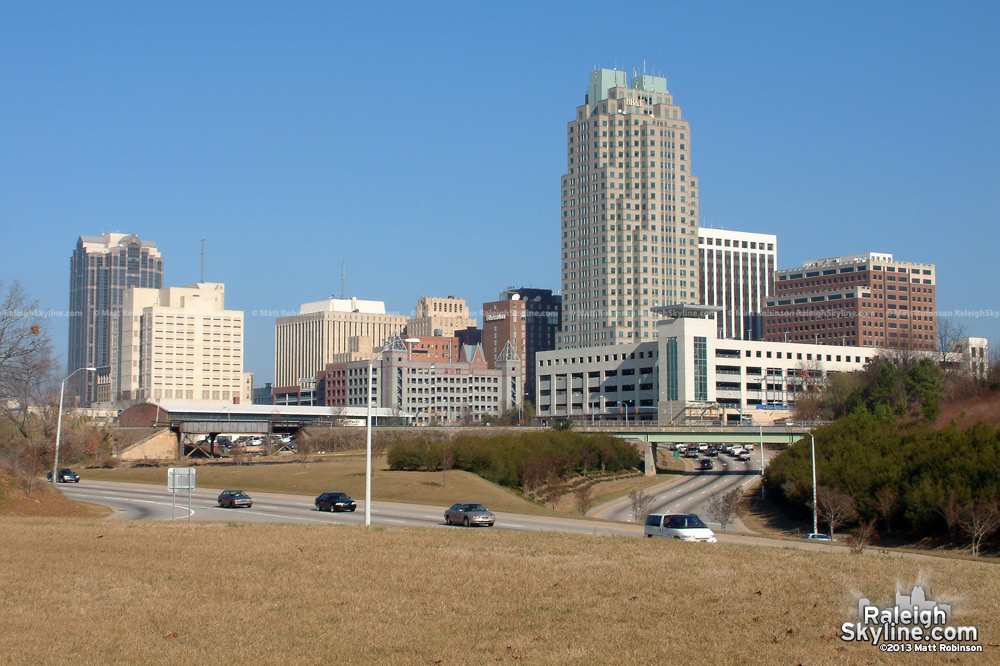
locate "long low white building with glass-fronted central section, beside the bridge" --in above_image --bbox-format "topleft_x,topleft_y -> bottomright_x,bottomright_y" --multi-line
535,306 -> 988,424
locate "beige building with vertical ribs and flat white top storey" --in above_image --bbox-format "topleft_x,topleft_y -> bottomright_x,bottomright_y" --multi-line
274,298 -> 410,388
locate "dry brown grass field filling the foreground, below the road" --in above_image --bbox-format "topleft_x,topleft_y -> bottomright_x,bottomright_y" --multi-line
0,518 -> 1000,666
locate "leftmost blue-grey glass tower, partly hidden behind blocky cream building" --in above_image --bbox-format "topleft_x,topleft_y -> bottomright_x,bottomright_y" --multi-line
66,233 -> 163,405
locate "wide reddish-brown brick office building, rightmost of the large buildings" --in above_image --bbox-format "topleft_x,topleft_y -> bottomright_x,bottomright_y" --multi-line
764,252 -> 937,350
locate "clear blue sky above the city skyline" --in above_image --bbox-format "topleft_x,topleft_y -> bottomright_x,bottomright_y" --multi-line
0,2 -> 1000,383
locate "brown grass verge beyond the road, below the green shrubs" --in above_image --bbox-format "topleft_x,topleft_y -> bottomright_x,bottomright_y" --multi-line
81,460 -> 665,517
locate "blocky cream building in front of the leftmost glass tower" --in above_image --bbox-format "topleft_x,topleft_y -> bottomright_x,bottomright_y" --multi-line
112,282 -> 244,403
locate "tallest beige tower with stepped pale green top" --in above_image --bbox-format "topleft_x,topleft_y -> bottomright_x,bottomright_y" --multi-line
556,69 -> 698,349
